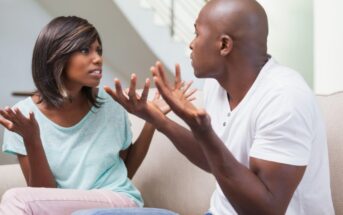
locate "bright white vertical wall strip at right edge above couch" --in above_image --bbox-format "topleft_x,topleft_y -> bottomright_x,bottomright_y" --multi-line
314,0 -> 343,94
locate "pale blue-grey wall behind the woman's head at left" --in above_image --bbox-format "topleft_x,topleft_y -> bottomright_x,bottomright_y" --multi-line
0,0 -> 127,164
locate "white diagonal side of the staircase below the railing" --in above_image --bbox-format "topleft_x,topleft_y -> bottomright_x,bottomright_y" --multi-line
113,0 -> 196,85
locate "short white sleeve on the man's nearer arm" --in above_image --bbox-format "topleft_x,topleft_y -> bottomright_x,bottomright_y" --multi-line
250,91 -> 313,166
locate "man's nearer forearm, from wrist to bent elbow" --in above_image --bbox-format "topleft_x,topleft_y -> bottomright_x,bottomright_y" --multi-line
196,131 -> 284,214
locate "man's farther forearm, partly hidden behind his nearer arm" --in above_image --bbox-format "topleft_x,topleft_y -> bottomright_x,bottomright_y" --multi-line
156,118 -> 211,172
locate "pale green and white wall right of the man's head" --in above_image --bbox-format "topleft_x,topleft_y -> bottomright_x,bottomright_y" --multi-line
258,0 -> 343,94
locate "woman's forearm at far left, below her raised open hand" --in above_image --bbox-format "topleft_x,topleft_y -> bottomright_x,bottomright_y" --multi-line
24,138 -> 56,187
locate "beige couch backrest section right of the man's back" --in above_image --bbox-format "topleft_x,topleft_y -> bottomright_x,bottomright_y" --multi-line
317,92 -> 343,214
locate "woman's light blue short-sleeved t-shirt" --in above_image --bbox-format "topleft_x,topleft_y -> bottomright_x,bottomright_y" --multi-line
2,89 -> 143,206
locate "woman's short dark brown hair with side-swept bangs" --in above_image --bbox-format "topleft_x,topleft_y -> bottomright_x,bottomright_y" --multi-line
32,16 -> 101,107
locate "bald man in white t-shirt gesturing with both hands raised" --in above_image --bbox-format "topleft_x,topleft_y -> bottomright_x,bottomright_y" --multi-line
105,0 -> 334,215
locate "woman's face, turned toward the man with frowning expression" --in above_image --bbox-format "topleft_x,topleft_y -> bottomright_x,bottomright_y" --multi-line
64,40 -> 102,90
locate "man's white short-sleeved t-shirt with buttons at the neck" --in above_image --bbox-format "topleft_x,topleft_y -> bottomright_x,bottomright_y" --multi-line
204,59 -> 334,215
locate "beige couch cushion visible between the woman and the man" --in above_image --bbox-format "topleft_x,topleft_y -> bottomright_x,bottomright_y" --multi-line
132,112 -> 215,214
